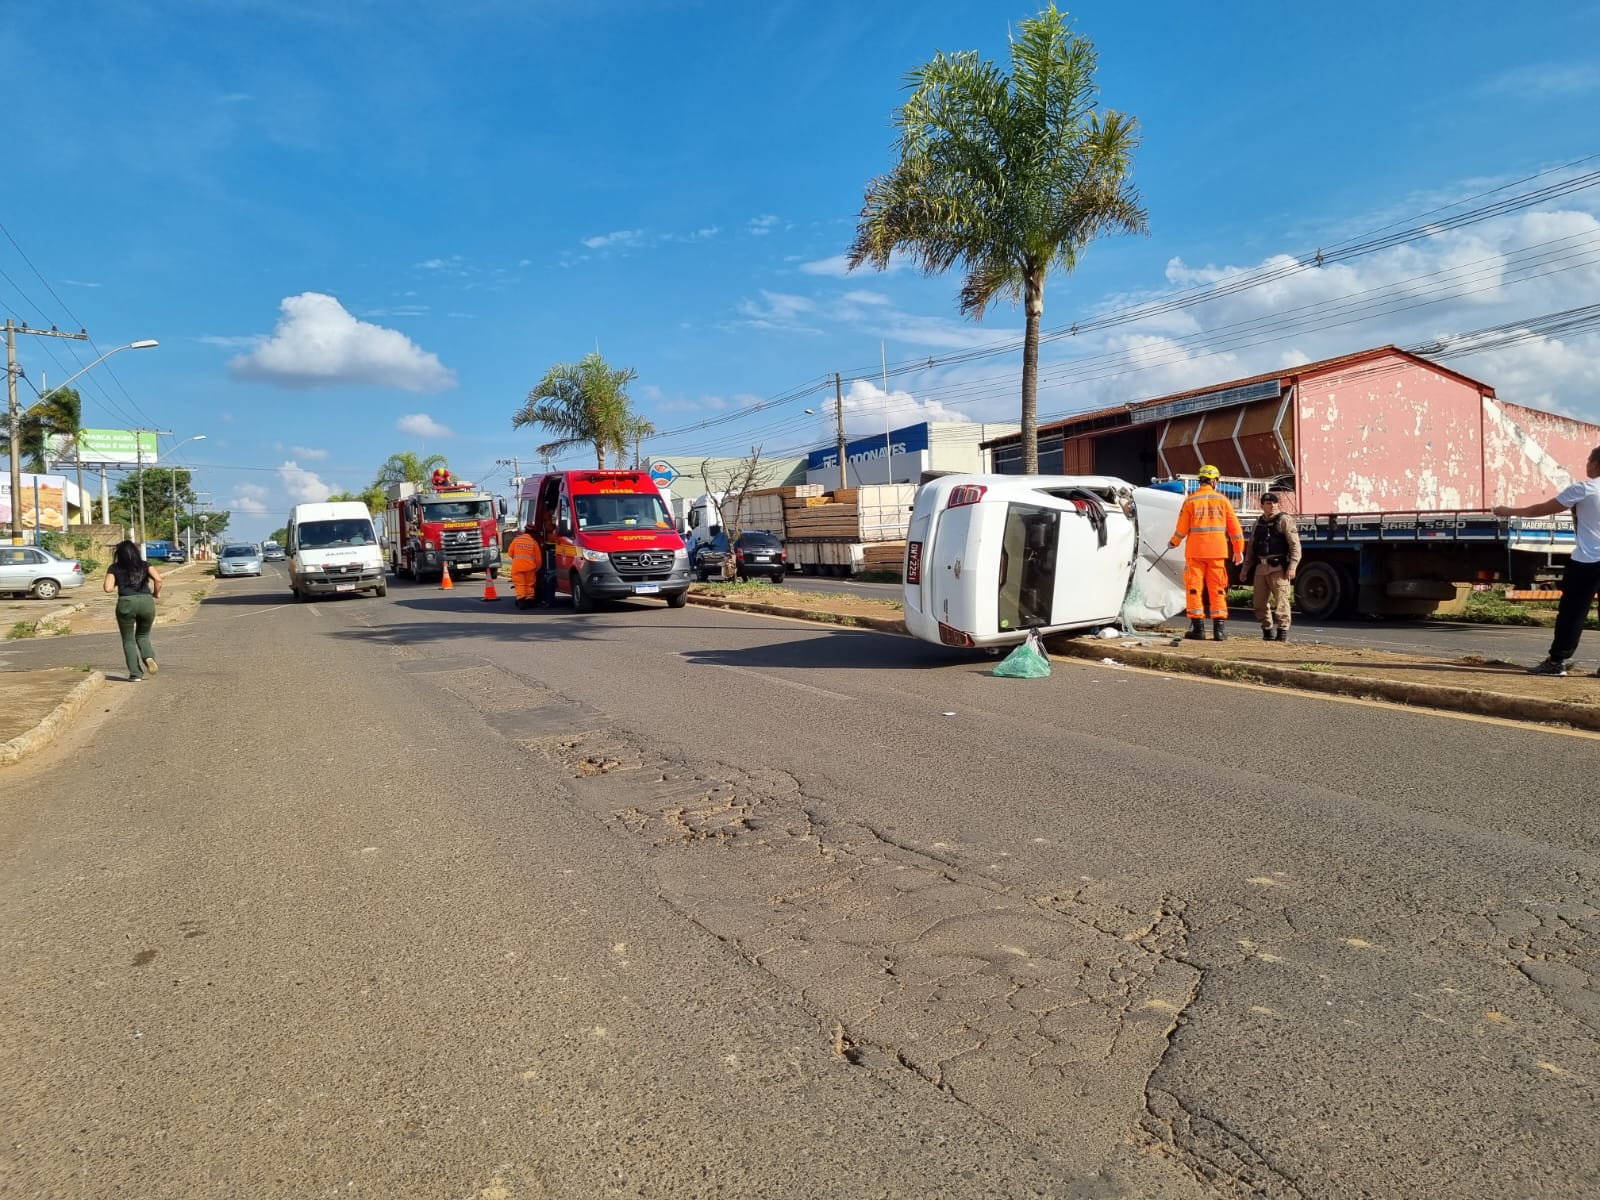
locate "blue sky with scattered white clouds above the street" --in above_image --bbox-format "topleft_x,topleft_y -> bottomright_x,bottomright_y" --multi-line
0,0 -> 1600,538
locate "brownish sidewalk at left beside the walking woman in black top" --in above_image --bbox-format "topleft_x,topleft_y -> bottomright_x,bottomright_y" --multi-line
0,563 -> 213,768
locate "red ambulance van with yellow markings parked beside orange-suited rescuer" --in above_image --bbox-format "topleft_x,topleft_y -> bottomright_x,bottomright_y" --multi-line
517,470 -> 690,613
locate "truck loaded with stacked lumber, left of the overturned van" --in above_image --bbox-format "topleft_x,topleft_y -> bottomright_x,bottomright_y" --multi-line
722,483 -> 917,574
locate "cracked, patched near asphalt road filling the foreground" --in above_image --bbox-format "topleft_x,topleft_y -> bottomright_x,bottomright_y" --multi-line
0,574 -> 1600,1200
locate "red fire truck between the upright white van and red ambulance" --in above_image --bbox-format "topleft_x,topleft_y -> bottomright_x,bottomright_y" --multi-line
384,480 -> 502,579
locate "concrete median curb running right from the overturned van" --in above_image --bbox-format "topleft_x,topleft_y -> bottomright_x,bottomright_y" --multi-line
1045,638 -> 1600,730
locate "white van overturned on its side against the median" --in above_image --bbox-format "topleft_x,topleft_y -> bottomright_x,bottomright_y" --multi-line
904,475 -> 1184,646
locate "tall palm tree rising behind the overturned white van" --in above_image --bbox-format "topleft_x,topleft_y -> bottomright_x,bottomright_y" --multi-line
848,5 -> 1146,474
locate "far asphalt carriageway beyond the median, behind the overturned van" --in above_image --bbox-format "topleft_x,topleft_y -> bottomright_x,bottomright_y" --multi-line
784,574 -> 1568,666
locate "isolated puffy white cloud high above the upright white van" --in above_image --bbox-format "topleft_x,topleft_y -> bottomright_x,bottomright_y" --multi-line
227,291 -> 456,392
